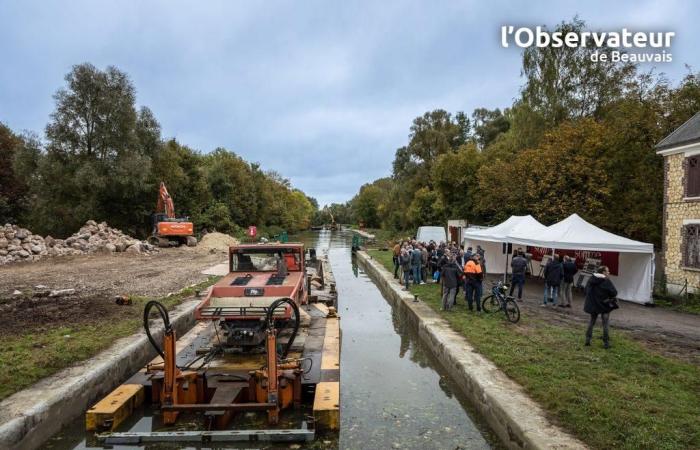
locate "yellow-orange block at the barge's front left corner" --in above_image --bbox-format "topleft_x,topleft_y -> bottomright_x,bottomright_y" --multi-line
85,384 -> 144,431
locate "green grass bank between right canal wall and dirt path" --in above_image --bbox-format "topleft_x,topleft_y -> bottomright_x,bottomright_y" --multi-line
369,250 -> 700,449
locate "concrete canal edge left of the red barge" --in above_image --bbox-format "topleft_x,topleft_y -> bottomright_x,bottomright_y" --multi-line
0,300 -> 199,449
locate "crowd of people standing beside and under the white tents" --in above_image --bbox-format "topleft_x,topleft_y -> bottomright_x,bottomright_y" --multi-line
393,239 -> 617,348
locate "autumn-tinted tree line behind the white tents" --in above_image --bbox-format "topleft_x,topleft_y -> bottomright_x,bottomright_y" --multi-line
348,18 -> 700,245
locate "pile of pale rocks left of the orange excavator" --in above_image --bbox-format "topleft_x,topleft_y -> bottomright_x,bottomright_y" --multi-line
0,220 -> 158,265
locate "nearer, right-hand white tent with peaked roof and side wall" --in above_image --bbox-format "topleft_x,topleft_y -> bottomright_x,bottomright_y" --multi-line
506,214 -> 654,303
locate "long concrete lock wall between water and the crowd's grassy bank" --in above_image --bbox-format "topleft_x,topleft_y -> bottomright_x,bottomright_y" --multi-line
357,252 -> 586,449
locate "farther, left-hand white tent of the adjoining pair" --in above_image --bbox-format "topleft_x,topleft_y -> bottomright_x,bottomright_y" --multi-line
464,215 -> 547,273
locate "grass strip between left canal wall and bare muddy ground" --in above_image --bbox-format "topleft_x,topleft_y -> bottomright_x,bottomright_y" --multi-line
0,277 -> 219,400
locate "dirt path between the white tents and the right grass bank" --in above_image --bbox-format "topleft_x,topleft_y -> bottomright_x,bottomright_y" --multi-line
484,278 -> 700,365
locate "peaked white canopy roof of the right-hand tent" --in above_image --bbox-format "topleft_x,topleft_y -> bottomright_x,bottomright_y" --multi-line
504,214 -> 654,253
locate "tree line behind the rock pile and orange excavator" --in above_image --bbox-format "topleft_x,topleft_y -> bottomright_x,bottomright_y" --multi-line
0,64 -> 318,237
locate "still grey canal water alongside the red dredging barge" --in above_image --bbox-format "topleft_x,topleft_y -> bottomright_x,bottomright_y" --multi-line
46,231 -> 499,450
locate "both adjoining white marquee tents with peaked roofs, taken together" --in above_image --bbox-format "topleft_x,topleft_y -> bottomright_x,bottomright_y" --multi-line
465,214 -> 654,303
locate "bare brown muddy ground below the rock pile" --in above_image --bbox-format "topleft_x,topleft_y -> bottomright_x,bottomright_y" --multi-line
0,247 -> 226,337
